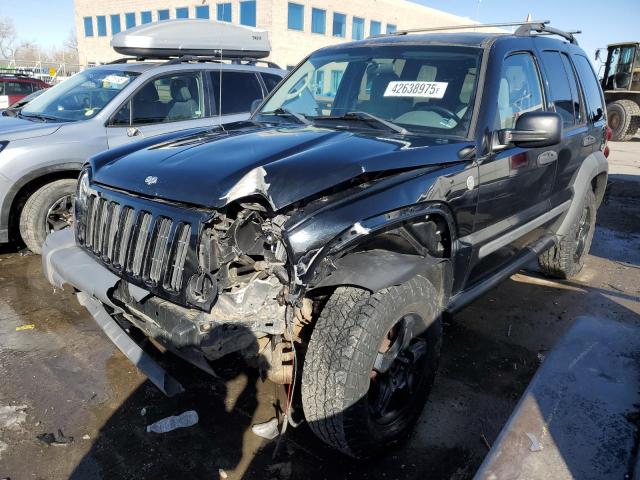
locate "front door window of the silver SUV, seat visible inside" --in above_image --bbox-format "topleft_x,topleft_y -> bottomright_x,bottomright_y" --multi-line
112,72 -> 204,125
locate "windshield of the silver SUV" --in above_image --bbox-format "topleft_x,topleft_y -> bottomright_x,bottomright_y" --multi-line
21,68 -> 139,121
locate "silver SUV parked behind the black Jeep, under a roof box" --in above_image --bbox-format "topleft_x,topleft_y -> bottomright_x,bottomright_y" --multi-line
0,56 -> 286,253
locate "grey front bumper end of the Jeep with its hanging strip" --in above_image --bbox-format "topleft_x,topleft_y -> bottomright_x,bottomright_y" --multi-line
42,229 -> 184,396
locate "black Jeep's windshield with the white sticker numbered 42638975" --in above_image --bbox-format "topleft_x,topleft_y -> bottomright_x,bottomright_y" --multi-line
260,45 -> 481,137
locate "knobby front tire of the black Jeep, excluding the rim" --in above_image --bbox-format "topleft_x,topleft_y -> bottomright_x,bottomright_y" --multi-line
301,276 -> 442,458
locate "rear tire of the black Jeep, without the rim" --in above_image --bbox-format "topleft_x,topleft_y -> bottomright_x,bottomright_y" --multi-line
538,189 -> 596,279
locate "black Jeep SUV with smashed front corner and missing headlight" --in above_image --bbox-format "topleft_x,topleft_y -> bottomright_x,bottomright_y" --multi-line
43,23 -> 609,457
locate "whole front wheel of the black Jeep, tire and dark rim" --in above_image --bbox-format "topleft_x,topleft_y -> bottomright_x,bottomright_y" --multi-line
302,276 -> 442,458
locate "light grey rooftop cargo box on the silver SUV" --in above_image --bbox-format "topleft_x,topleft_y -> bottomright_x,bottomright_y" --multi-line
111,19 -> 271,58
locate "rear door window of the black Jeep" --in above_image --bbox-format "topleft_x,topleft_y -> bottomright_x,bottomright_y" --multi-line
542,50 -> 581,128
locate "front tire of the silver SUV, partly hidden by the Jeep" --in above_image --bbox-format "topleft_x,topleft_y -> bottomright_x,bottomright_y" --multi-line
20,178 -> 78,255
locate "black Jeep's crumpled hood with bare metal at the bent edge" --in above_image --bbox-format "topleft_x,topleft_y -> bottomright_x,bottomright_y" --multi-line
91,124 -> 471,210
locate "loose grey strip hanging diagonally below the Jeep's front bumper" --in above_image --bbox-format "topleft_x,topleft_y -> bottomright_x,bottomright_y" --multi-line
76,292 -> 184,397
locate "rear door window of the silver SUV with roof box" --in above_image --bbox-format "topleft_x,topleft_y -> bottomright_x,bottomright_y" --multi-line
209,71 -> 262,115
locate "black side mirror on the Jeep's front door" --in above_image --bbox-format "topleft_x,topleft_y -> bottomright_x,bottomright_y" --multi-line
498,112 -> 562,148
